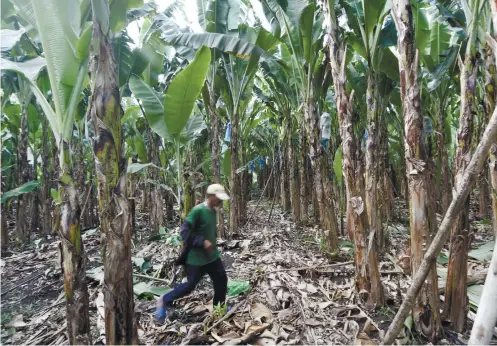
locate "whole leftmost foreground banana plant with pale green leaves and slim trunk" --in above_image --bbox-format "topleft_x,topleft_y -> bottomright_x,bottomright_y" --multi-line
2,0 -> 91,343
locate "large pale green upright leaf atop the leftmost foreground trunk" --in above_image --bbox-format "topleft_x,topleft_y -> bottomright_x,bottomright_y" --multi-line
13,0 -> 91,144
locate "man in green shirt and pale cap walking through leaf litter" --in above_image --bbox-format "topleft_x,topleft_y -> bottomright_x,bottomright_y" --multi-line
156,184 -> 229,323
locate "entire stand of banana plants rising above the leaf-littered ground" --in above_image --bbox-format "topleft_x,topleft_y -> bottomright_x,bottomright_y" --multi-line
1,0 -> 497,344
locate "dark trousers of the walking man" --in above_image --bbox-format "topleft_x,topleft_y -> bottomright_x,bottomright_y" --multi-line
163,258 -> 228,306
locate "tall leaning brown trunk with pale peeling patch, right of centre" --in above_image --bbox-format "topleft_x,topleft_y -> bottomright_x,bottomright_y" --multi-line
326,2 -> 385,307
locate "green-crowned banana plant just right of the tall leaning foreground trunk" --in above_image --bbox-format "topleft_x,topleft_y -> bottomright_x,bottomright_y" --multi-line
345,0 -> 399,251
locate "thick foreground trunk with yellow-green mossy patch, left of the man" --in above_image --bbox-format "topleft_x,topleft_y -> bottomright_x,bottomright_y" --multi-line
88,0 -> 138,345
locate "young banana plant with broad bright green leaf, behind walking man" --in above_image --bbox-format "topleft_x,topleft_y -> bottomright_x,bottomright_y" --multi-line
129,47 -> 211,219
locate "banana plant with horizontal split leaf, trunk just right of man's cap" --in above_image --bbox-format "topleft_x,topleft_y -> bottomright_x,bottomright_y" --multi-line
143,1 -> 277,232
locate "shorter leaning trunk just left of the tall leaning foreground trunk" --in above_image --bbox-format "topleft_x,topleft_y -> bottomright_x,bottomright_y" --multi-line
304,84 -> 338,252
